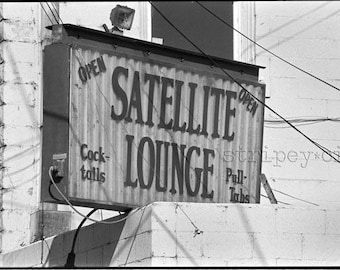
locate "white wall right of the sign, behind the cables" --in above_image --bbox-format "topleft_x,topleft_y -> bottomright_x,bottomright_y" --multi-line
255,1 -> 340,207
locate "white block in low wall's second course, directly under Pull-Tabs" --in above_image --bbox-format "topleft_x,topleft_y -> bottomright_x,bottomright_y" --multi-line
203,232 -> 253,259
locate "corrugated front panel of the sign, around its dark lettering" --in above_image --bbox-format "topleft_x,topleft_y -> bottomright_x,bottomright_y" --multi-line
68,47 -> 264,205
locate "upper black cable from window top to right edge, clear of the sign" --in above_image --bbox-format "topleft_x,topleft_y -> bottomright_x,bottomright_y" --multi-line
196,1 -> 340,91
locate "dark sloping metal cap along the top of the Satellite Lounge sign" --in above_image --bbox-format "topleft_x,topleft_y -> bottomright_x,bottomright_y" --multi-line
46,24 -> 265,77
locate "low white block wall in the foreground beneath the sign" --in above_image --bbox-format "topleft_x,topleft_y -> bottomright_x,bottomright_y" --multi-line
1,202 -> 340,267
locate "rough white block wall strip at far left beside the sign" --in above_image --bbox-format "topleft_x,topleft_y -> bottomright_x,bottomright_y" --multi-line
0,3 -> 42,251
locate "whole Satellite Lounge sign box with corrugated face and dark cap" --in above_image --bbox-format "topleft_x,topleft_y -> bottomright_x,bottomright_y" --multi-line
42,25 -> 265,210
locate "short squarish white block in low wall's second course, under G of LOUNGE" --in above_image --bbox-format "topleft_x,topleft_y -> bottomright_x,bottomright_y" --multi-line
176,232 -> 205,258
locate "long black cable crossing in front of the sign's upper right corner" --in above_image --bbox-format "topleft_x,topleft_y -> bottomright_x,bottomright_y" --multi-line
149,1 -> 340,163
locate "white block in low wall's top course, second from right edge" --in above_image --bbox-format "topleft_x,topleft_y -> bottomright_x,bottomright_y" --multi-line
276,208 -> 325,234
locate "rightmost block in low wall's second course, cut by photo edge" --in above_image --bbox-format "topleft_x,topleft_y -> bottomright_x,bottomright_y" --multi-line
303,234 -> 340,263
